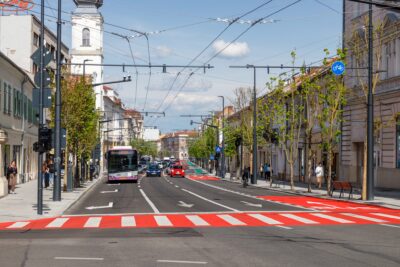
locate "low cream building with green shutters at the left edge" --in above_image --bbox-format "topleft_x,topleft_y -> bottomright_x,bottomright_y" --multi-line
0,52 -> 38,196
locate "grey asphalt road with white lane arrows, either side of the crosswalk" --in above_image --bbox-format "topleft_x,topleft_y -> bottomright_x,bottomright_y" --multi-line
0,169 -> 400,267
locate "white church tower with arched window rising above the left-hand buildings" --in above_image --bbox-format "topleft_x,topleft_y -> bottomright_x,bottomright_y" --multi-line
70,0 -> 104,110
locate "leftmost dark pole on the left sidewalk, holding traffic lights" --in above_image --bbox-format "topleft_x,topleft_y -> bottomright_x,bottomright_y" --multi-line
37,0 -> 44,215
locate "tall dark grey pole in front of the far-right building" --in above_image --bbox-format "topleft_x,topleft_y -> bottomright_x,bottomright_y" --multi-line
367,4 -> 374,200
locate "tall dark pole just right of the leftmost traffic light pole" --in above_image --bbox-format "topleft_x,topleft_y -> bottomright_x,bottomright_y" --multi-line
53,0 -> 65,201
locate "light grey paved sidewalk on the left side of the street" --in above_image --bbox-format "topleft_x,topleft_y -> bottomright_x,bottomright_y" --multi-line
0,178 -> 101,222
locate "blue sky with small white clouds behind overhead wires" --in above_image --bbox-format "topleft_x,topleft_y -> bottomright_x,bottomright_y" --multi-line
35,0 -> 342,133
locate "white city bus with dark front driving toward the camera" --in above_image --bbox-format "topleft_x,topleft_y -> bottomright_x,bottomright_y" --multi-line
106,146 -> 138,182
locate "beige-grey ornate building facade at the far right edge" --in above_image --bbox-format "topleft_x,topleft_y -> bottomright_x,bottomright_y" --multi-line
340,1 -> 400,189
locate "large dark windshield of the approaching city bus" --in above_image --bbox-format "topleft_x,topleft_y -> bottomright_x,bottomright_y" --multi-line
108,150 -> 138,173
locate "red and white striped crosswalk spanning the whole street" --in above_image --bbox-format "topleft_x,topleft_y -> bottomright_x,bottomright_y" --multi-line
0,211 -> 400,231
